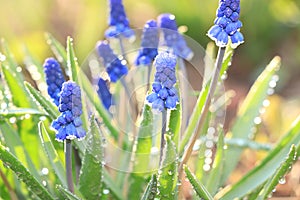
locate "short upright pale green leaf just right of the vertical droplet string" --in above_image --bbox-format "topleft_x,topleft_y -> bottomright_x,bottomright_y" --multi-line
206,131 -> 224,194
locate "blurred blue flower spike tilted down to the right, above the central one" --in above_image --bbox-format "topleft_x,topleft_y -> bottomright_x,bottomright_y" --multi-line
158,13 -> 193,60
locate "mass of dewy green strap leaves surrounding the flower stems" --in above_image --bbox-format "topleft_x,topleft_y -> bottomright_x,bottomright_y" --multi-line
0,7 -> 300,200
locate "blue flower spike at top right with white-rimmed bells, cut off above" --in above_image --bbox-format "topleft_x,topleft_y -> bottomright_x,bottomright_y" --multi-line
207,0 -> 244,48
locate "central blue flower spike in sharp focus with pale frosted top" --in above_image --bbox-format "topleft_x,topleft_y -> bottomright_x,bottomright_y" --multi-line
146,52 -> 179,112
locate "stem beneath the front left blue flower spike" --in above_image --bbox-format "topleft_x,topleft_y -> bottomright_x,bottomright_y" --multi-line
65,139 -> 74,193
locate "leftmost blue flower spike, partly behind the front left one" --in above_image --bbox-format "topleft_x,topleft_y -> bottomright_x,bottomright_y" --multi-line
43,58 -> 66,106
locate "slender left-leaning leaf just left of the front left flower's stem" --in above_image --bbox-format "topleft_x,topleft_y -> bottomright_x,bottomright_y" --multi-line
38,122 -> 68,187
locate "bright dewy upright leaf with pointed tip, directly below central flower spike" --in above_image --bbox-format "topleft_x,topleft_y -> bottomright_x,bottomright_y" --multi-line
158,135 -> 178,199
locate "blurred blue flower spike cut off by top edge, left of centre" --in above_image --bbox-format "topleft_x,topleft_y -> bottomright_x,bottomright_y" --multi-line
105,0 -> 134,38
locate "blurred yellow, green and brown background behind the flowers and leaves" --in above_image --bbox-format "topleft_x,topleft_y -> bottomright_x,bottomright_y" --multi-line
0,0 -> 300,195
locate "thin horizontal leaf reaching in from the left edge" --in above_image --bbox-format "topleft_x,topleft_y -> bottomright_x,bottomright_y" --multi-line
0,108 -> 47,118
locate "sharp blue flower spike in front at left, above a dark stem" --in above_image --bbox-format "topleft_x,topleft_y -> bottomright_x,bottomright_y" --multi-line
51,81 -> 86,142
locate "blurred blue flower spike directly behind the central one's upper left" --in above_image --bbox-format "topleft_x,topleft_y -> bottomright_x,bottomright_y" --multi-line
135,20 -> 159,66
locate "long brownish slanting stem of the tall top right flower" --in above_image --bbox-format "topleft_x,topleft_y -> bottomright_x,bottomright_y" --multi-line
179,47 -> 225,179
